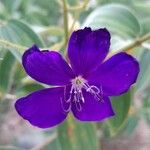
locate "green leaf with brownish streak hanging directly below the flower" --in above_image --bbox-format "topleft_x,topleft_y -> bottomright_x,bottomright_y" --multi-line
58,116 -> 98,150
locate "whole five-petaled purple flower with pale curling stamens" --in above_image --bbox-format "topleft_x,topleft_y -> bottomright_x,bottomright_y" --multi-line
15,28 -> 139,128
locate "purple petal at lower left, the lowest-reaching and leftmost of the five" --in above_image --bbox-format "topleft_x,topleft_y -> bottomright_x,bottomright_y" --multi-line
15,88 -> 67,128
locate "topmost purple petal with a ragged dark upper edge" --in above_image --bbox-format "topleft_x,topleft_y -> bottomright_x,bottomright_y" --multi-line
68,28 -> 110,76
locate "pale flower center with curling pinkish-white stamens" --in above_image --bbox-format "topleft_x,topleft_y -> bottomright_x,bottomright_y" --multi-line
62,76 -> 103,112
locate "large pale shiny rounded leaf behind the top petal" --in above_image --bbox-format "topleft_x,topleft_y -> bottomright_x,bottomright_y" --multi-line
83,4 -> 140,38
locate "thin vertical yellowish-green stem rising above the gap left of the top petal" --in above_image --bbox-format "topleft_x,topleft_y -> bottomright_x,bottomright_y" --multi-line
62,0 -> 68,46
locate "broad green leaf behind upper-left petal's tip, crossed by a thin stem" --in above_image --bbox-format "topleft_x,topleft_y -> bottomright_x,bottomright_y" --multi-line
0,20 -> 43,61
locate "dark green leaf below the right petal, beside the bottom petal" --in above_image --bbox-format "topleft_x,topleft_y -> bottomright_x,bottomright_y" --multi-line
104,91 -> 131,136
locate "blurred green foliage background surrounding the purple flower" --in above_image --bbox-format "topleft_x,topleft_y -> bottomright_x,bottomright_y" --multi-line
0,0 -> 150,150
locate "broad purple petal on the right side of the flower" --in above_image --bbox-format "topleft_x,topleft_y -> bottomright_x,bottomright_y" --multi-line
87,52 -> 139,96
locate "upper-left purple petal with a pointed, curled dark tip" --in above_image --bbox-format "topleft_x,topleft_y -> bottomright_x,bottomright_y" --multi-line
22,45 -> 74,85
